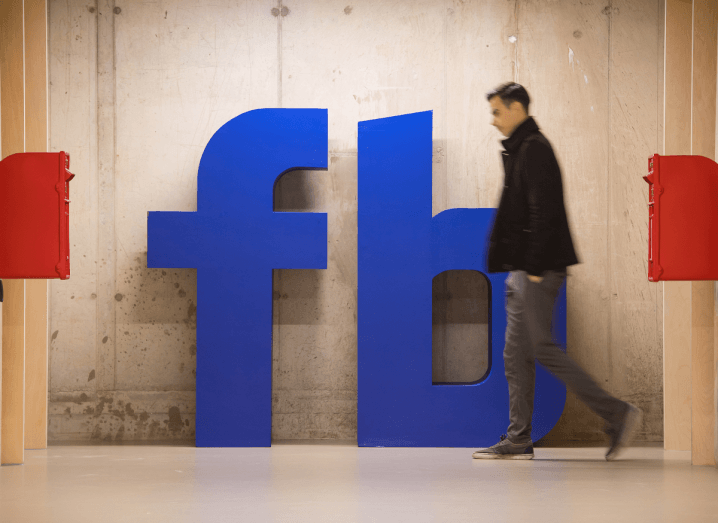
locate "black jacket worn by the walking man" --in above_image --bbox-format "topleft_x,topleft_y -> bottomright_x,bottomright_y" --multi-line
488,118 -> 578,276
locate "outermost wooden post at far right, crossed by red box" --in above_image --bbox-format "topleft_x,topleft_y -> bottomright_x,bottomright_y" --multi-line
691,0 -> 718,465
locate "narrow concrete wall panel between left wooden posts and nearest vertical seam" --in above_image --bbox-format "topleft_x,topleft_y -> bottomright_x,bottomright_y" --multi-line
48,2 -> 102,398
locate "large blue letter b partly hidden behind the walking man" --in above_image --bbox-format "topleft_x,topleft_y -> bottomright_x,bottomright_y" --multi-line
358,112 -> 566,447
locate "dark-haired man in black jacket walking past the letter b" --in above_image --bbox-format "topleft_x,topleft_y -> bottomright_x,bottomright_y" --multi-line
473,83 -> 641,460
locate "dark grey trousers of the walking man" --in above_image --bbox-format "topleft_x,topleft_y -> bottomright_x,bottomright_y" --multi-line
504,271 -> 627,443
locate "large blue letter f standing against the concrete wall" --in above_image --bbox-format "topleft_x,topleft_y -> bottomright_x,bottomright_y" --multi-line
147,109 -> 328,447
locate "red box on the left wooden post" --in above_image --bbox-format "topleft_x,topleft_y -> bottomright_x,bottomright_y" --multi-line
0,152 -> 74,280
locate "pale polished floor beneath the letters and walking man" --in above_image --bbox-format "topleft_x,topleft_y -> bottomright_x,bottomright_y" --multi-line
0,444 -> 718,523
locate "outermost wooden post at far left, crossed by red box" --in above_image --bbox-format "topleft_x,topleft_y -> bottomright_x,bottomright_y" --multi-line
0,0 -> 25,465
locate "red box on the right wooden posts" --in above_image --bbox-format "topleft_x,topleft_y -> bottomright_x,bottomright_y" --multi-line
644,154 -> 718,281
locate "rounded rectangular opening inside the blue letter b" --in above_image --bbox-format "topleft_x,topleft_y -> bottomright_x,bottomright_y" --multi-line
431,271 -> 490,385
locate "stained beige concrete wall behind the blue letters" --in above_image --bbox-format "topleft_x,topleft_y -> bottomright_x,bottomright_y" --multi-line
49,0 -> 663,441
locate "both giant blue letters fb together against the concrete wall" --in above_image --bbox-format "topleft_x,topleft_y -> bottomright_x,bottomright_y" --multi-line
147,109 -> 566,447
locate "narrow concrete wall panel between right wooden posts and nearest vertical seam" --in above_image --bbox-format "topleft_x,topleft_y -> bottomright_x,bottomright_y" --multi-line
608,0 -> 663,440
